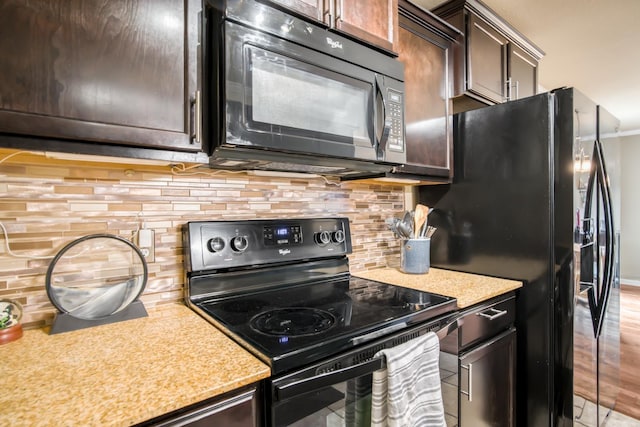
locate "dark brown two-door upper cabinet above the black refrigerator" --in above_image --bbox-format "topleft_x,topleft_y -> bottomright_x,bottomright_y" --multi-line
432,0 -> 544,112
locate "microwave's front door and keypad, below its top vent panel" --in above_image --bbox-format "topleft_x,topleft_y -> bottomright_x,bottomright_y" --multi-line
212,21 -> 406,164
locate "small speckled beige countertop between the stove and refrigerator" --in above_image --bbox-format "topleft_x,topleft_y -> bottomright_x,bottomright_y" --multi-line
353,267 -> 522,308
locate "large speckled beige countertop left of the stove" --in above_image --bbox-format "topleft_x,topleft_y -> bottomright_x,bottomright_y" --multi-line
0,303 -> 270,427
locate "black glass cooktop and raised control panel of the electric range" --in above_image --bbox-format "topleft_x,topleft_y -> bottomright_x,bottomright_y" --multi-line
183,218 -> 456,374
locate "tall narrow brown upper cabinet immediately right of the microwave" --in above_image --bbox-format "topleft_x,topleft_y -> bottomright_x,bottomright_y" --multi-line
396,0 -> 463,181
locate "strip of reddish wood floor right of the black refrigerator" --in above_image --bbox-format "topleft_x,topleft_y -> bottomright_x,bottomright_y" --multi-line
616,285 -> 640,420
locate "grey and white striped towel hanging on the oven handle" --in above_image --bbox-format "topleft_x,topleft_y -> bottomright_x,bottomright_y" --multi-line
371,332 -> 446,427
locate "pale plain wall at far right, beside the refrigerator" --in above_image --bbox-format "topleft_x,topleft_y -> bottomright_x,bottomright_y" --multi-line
620,135 -> 640,285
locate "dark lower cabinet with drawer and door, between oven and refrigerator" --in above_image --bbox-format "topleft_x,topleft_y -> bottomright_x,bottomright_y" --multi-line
440,293 -> 516,427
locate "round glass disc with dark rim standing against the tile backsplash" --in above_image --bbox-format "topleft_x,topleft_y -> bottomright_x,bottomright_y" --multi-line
46,234 -> 147,333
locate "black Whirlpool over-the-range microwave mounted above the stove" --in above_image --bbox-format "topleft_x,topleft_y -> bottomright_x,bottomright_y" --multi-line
203,0 -> 406,178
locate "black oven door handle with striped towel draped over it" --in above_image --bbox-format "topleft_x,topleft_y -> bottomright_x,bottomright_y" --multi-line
274,317 -> 463,400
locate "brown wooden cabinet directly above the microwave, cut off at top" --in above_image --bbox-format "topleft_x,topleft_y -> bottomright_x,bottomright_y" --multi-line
270,0 -> 398,51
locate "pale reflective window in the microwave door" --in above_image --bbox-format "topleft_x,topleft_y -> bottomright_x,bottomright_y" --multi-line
248,47 -> 373,146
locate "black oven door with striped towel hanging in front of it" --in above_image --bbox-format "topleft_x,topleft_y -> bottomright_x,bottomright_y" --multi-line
267,318 -> 461,427
